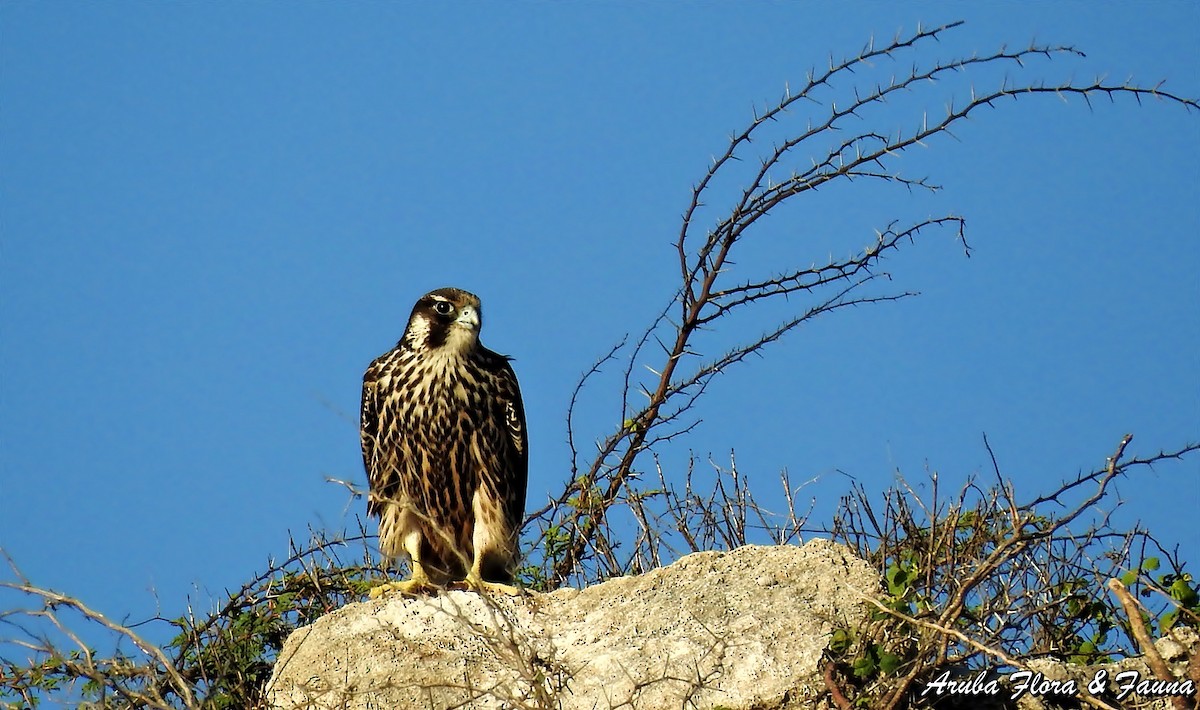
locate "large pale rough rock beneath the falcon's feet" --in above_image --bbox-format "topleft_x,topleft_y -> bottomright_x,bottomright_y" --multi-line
268,540 -> 878,710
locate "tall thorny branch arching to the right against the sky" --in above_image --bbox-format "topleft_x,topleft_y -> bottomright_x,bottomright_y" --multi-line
526,23 -> 1200,588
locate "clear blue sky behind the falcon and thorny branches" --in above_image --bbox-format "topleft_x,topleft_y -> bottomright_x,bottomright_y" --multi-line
0,2 -> 1200,652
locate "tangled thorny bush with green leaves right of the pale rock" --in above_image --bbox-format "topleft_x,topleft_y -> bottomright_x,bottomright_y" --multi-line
830,435 -> 1200,708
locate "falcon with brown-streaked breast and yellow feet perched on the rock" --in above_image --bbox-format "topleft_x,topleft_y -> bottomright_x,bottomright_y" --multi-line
361,288 -> 529,597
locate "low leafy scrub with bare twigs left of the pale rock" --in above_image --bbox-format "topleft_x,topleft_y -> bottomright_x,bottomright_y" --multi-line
0,530 -> 379,709
